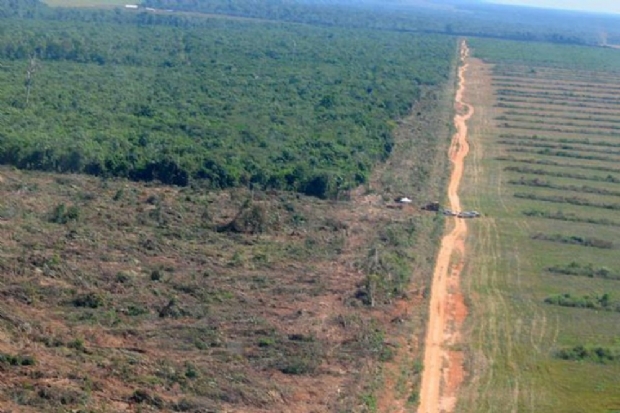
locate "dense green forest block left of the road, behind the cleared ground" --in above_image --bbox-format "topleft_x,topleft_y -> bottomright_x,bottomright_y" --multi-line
0,3 -> 455,197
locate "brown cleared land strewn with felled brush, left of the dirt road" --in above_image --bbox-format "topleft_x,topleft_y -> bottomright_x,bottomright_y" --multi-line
0,76 -> 453,412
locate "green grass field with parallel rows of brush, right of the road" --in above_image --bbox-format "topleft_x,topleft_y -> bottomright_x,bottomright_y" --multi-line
457,41 -> 620,413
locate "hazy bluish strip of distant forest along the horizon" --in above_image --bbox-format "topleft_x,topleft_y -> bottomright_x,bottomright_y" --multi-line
142,0 -> 620,45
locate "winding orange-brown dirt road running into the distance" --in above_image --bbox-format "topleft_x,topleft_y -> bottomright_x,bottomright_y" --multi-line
418,42 -> 474,413
